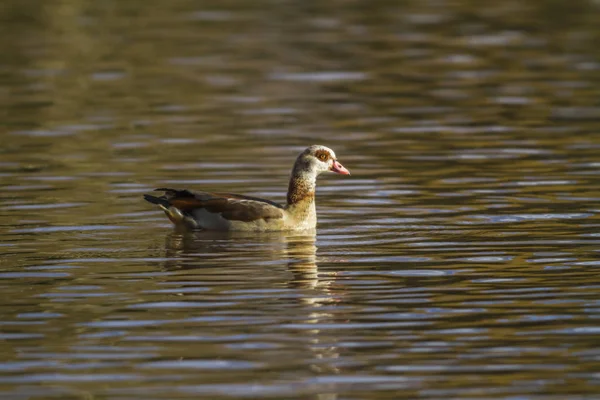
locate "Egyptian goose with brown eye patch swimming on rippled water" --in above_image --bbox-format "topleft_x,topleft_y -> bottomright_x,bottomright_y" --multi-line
144,145 -> 350,231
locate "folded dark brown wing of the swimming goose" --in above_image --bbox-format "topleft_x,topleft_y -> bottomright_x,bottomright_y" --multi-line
156,188 -> 283,222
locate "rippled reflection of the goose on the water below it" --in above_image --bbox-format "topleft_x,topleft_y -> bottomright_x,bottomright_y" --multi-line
165,230 -> 340,400
